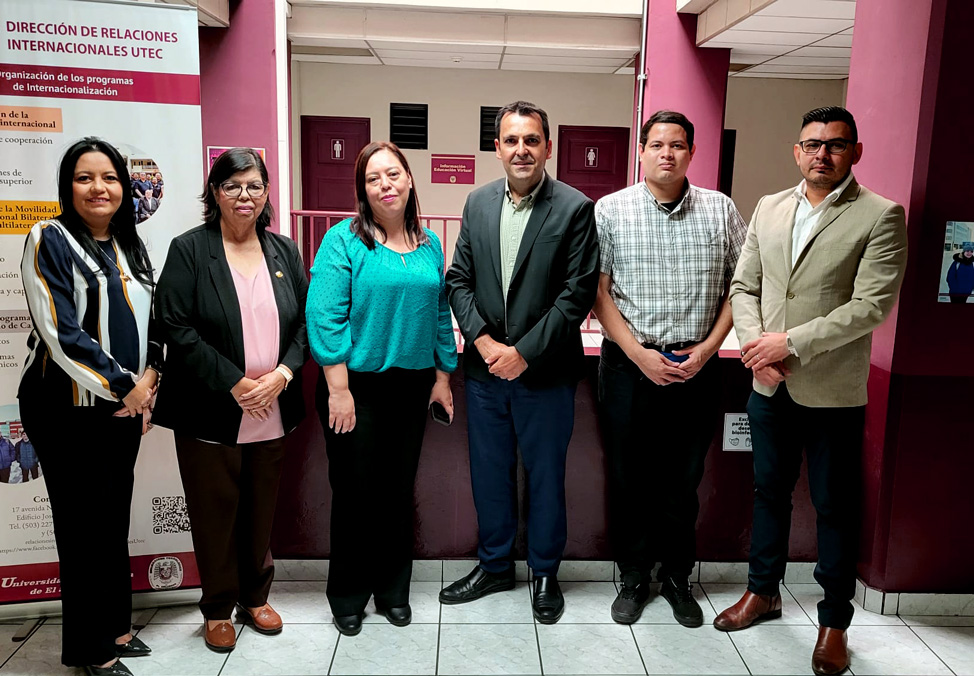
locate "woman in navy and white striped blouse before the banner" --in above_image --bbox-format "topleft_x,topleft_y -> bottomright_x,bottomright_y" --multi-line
18,137 -> 162,675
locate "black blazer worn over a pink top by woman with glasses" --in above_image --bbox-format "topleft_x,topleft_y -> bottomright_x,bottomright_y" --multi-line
152,223 -> 308,446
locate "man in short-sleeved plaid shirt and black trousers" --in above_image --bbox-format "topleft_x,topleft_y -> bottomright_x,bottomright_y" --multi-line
595,110 -> 747,627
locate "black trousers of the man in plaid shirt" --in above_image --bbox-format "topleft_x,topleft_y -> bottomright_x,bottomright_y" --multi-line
599,340 -> 720,584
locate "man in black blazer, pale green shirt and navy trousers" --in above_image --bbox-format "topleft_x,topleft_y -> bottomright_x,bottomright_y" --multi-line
440,101 -> 599,623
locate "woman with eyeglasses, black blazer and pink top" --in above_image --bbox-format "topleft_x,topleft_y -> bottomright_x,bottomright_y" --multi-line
154,148 -> 308,652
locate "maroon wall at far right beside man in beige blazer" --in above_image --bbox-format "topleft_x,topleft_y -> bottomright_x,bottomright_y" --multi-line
848,0 -> 974,592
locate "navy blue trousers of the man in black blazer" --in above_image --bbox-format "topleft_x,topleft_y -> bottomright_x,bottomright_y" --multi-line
467,377 -> 575,577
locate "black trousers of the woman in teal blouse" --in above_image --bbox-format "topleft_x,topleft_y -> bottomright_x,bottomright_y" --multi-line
316,368 -> 435,616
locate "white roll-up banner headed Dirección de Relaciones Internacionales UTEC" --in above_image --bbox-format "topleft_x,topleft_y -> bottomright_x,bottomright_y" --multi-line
0,0 -> 204,603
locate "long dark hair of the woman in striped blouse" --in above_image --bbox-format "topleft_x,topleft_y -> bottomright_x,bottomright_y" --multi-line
57,136 -> 153,286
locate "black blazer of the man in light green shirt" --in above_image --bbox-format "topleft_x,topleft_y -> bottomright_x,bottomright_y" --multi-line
446,176 -> 599,387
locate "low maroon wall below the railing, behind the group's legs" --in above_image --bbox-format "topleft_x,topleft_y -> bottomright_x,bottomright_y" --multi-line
273,357 -> 816,561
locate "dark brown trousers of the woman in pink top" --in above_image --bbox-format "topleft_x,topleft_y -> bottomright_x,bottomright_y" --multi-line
176,435 -> 284,620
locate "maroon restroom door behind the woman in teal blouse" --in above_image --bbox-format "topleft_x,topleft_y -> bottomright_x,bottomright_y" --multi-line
301,115 -> 372,211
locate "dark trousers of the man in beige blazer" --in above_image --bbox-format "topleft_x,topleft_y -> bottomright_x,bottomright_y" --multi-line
747,384 -> 866,629
